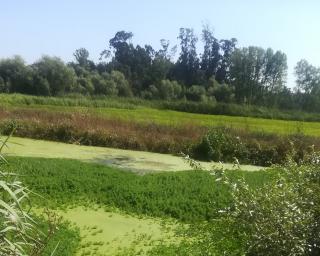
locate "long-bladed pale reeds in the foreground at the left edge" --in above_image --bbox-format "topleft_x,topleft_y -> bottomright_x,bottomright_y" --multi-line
0,140 -> 46,256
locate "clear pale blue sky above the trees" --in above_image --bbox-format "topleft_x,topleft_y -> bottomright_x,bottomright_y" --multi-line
0,0 -> 320,87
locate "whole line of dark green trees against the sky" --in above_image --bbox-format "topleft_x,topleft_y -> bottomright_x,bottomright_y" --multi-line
0,25 -> 320,111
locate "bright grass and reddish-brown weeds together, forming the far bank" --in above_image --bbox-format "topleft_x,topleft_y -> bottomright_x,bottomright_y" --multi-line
0,101 -> 320,166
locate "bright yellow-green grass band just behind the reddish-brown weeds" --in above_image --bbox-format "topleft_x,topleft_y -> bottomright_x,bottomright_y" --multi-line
3,95 -> 320,136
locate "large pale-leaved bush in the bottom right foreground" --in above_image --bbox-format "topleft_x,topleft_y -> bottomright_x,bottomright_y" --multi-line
210,153 -> 320,256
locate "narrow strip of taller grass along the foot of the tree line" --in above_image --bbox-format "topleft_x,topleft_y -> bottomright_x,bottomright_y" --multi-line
0,94 -> 320,121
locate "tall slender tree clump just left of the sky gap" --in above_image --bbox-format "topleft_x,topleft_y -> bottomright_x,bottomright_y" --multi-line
230,46 -> 287,104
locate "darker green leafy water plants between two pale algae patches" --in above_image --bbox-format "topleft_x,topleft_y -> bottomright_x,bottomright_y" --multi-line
7,157 -> 271,222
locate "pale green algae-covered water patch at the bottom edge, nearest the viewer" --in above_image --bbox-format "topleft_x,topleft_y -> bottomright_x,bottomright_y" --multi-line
59,207 -> 179,256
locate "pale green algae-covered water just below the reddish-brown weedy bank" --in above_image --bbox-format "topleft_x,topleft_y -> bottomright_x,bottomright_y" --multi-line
4,137 -> 261,173
